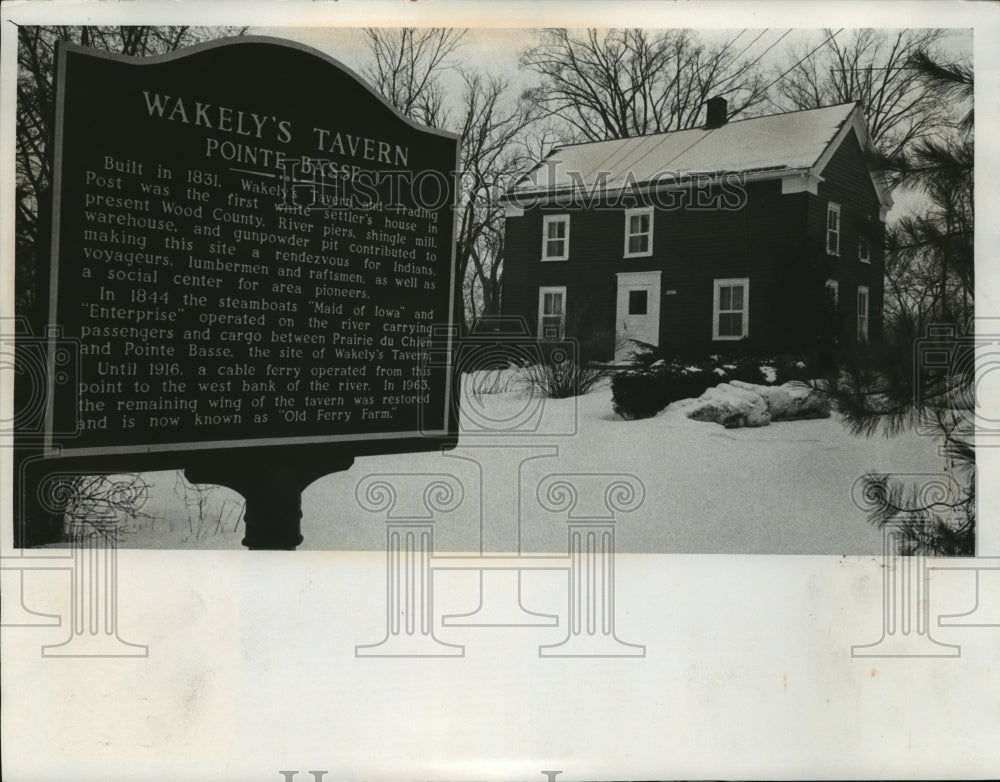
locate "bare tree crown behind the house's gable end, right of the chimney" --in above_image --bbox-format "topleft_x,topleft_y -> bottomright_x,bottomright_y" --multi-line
776,29 -> 949,160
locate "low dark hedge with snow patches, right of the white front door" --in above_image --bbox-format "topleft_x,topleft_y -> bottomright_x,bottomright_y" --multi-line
611,355 -> 811,420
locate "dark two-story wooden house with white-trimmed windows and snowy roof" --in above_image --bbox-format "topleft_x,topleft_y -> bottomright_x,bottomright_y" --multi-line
502,98 -> 892,359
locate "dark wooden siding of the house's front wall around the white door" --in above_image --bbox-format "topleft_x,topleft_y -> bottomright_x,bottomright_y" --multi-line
503,182 -> 806,352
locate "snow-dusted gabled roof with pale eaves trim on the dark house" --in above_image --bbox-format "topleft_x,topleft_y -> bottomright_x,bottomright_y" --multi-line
507,103 -> 892,216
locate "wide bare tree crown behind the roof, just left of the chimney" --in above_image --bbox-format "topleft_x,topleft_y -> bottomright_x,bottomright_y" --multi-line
521,29 -> 765,141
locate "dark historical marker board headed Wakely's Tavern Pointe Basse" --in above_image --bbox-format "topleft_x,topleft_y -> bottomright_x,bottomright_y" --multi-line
43,38 -> 457,455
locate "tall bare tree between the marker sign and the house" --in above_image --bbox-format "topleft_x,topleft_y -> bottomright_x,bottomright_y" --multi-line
364,28 -> 540,320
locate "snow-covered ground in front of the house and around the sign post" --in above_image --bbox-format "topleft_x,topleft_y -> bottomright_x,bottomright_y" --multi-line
103,376 -> 944,555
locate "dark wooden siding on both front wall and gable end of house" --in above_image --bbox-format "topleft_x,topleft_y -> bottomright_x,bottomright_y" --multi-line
502,127 -> 883,358
